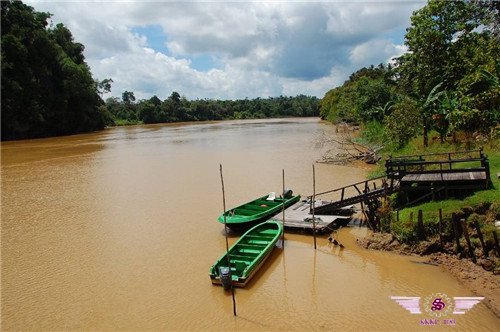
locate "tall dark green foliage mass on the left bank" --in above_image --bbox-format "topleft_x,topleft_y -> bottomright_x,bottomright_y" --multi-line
1,1 -> 106,140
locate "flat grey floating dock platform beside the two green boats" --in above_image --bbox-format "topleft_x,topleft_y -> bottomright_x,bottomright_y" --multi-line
271,200 -> 354,234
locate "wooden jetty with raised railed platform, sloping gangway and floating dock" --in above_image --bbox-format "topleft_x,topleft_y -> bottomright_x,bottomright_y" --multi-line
294,149 -> 491,230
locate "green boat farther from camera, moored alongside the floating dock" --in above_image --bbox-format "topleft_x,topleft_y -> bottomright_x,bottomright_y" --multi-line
217,190 -> 300,231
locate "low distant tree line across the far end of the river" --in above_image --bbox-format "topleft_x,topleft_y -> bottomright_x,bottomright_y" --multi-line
101,91 -> 319,125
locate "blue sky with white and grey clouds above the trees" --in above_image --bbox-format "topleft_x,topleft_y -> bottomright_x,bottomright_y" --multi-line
25,0 -> 425,100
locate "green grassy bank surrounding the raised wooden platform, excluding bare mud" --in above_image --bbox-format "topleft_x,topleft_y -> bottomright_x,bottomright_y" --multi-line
360,124 -> 500,246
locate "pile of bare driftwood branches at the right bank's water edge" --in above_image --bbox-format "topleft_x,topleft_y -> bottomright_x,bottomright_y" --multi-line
316,133 -> 382,165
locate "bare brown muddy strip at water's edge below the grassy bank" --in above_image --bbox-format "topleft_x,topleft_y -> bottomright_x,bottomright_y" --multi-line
357,233 -> 500,318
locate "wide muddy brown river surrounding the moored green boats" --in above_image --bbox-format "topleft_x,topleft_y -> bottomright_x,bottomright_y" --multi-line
1,119 -> 499,331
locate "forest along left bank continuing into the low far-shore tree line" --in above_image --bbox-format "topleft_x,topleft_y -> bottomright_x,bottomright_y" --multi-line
1,1 -> 319,140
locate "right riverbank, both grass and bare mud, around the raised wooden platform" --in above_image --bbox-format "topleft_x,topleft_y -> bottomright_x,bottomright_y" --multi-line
344,124 -> 500,318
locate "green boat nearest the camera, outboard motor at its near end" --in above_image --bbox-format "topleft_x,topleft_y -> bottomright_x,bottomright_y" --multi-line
210,221 -> 283,289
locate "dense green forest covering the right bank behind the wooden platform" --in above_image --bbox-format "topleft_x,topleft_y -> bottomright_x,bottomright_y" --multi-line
320,0 -> 500,147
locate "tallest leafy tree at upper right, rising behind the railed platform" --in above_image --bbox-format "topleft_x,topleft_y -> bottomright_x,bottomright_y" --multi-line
396,0 -> 500,145
